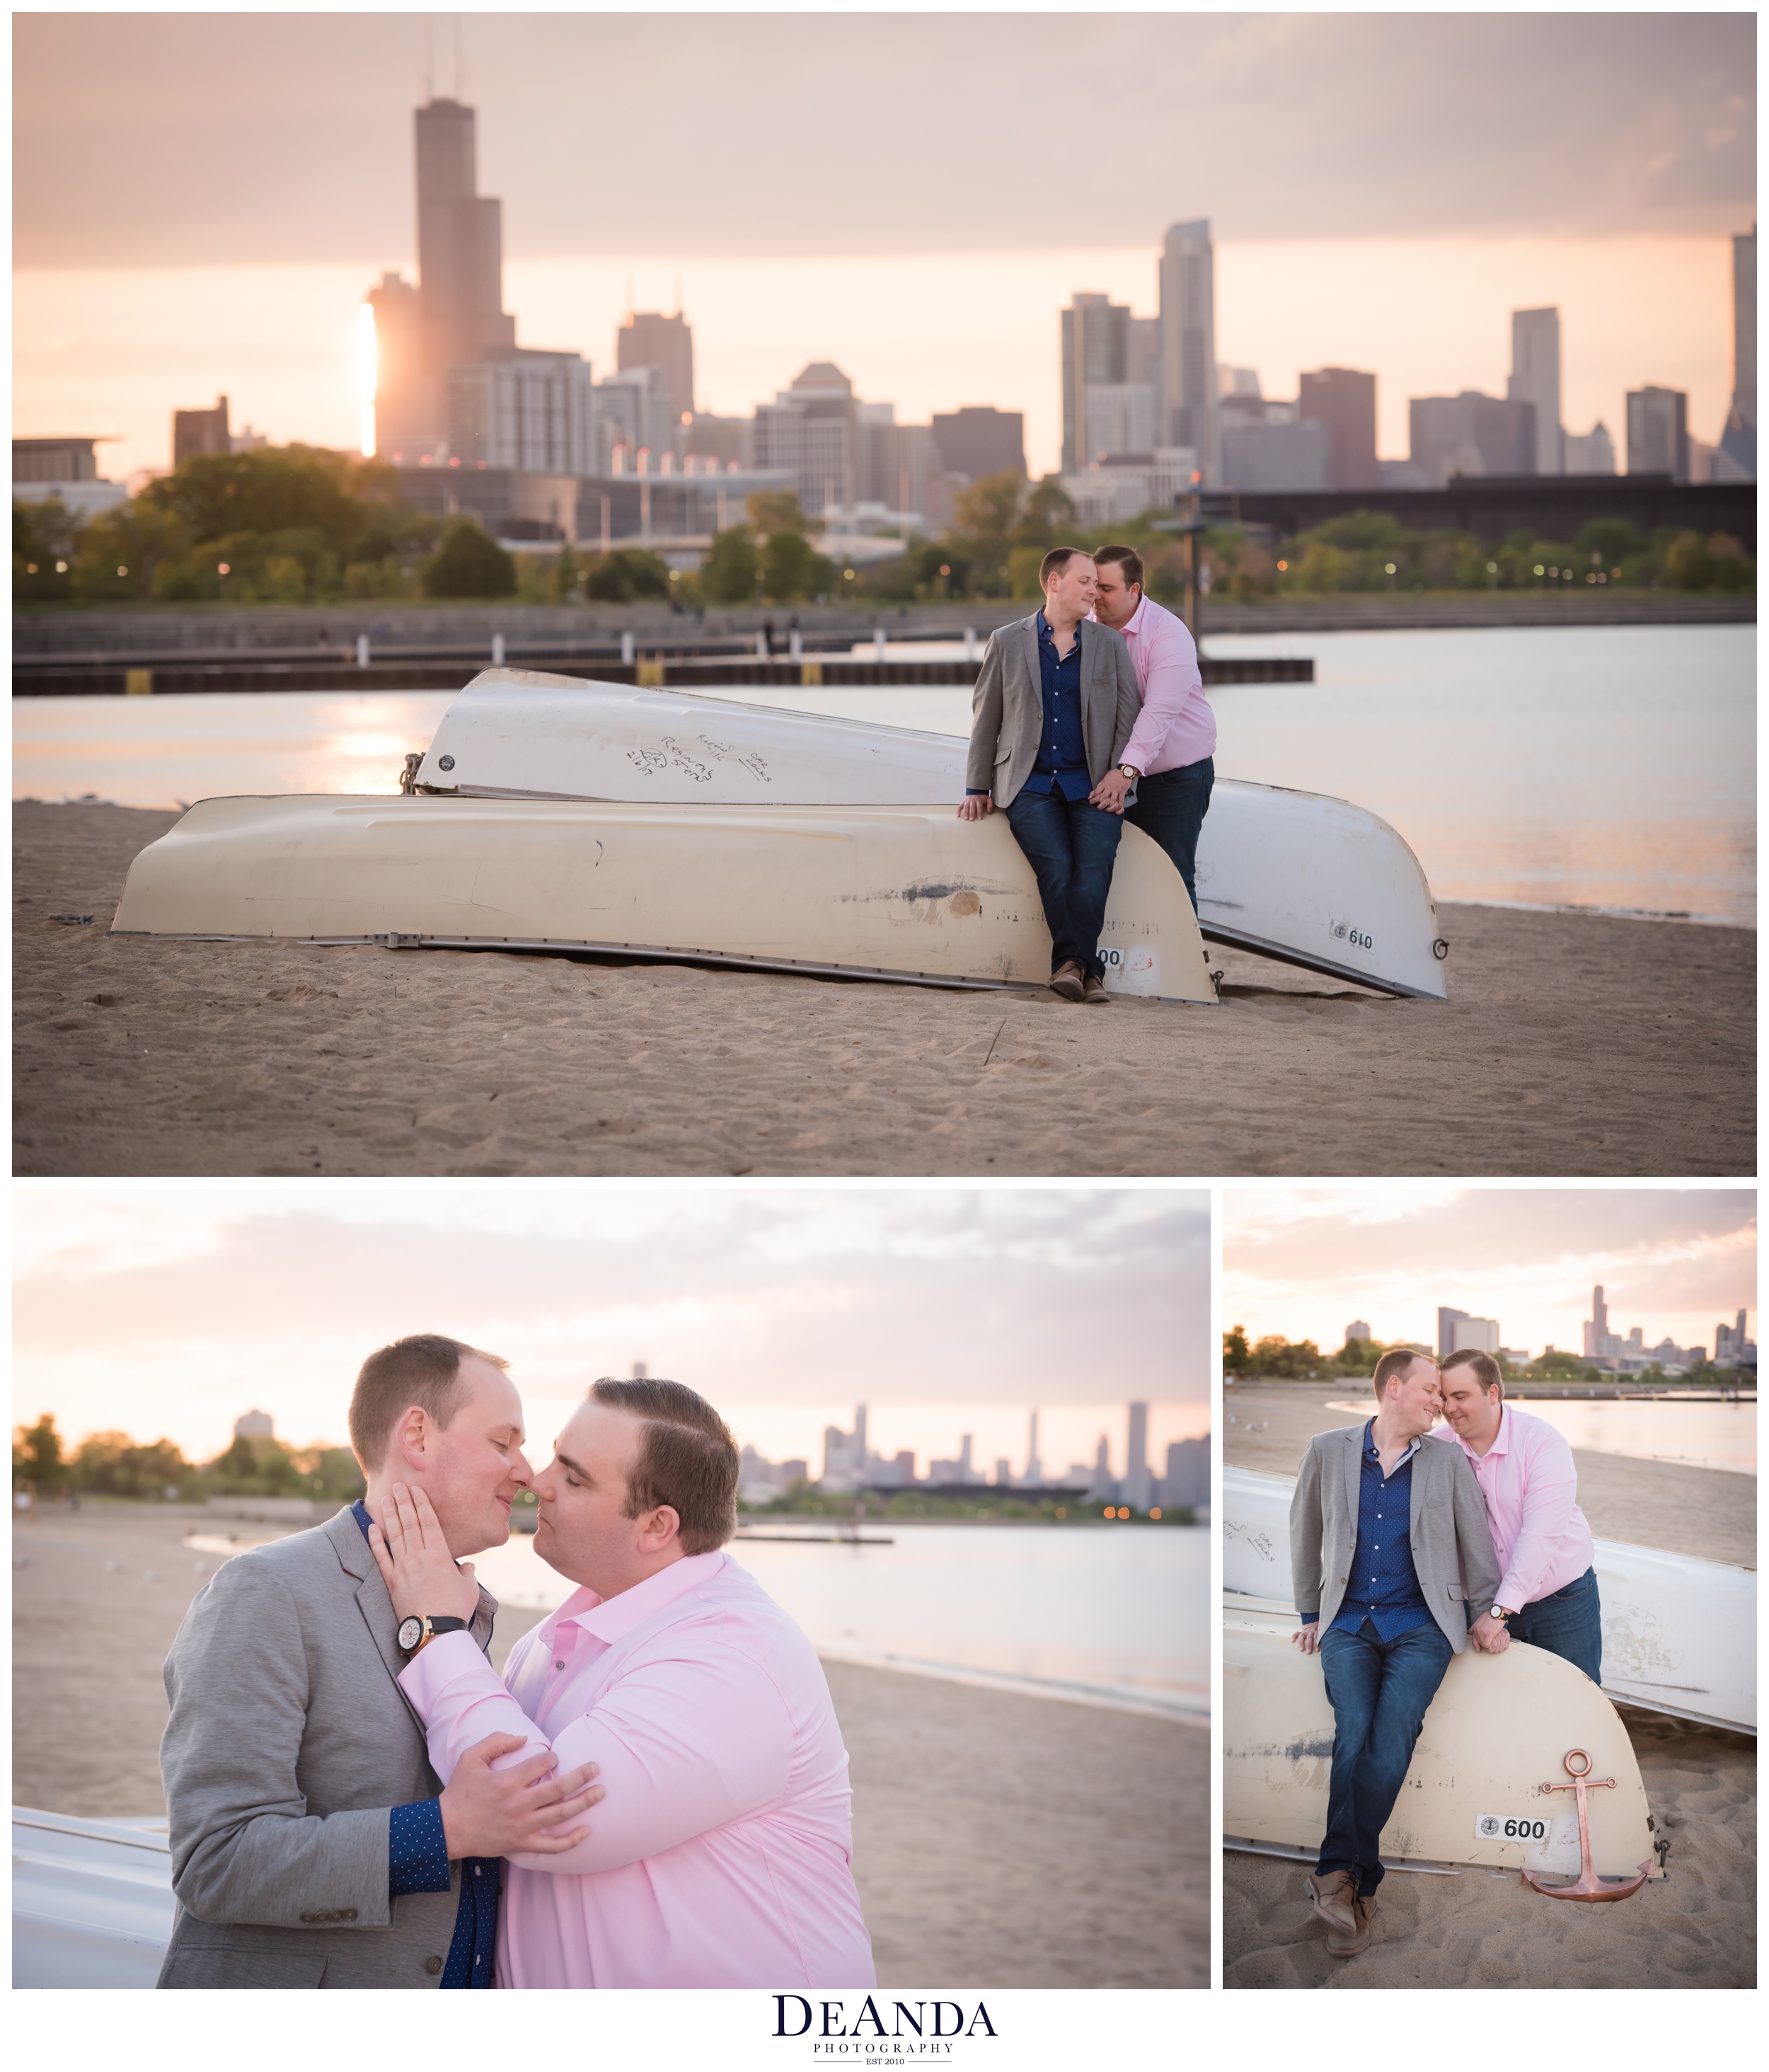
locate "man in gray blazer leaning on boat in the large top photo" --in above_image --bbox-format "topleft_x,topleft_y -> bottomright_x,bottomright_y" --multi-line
959,547 -> 1141,1007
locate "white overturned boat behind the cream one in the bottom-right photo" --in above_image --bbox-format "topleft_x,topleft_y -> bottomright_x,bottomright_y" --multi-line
1222,1467 -> 1756,1734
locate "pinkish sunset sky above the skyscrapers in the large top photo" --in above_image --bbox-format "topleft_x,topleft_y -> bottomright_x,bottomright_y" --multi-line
14,11 -> 1755,475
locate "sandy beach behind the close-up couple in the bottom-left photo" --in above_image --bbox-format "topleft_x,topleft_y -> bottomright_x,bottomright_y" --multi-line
13,1502 -> 1210,1987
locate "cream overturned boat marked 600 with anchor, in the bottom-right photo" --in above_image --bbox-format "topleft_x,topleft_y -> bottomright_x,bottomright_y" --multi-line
1222,1597 -> 1664,1906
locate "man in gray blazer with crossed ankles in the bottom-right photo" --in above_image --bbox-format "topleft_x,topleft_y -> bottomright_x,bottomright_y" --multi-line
1291,1351 -> 1499,1956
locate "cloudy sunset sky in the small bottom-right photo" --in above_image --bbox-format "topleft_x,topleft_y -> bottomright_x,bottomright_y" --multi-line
1222,1187 -> 1756,1353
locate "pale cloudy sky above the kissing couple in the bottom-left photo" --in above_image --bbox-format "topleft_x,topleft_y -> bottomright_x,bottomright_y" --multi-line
13,1183 -> 1210,1473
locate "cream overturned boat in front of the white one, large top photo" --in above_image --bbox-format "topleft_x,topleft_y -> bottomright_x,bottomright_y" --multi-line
112,793 -> 1216,1001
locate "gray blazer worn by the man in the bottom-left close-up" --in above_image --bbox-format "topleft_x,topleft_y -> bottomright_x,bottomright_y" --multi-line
159,1508 -> 499,1989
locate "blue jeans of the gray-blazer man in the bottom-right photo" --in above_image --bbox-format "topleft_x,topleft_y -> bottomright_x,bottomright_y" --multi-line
1315,1618 -> 1454,1898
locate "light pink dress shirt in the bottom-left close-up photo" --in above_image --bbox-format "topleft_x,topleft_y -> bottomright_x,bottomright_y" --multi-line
400,1554 -> 876,1989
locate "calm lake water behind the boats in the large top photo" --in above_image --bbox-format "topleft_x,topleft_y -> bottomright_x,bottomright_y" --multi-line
13,626 -> 1756,926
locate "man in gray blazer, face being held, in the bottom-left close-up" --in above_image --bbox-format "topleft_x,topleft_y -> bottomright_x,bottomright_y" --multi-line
159,1337 -> 601,1989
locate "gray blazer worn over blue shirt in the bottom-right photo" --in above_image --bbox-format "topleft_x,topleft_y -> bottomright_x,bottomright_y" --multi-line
1291,1424 -> 1499,1654
